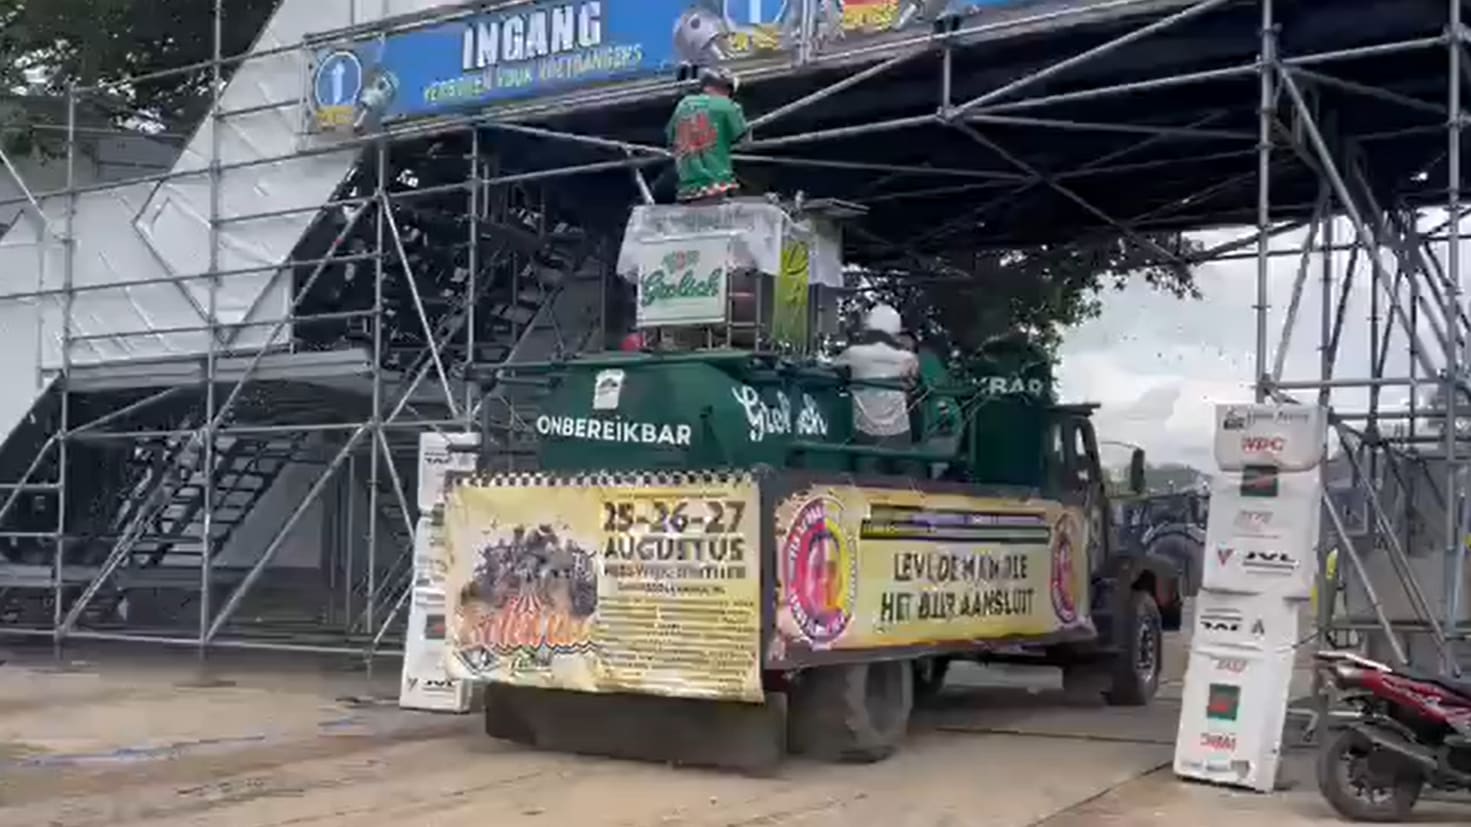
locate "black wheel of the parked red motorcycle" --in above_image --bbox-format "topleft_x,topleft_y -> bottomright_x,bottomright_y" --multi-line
1318,730 -> 1425,823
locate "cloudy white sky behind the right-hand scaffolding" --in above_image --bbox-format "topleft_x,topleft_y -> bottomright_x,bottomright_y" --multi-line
1059,221 -> 1440,471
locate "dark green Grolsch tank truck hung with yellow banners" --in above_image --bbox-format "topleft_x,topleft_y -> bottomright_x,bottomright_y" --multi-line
443,192 -> 1174,767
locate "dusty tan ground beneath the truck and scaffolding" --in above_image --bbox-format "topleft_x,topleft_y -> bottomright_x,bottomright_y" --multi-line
0,638 -> 1471,827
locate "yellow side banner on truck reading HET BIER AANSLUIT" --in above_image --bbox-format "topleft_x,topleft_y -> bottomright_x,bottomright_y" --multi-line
772,486 -> 1091,653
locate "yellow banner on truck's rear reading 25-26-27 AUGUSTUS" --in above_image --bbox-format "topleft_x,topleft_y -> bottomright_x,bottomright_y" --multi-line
444,475 -> 763,703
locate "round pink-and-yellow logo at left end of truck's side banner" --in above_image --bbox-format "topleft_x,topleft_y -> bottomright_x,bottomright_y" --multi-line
781,497 -> 858,645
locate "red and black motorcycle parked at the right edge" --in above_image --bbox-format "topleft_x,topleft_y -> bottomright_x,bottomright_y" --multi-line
1317,652 -> 1471,821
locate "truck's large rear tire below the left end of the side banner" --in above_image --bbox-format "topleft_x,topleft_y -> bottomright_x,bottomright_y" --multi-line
788,661 -> 913,764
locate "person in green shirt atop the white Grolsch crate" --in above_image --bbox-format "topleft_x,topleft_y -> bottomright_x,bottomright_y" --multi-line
666,68 -> 747,202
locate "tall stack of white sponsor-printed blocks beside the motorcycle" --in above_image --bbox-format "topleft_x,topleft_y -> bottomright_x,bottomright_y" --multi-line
1175,405 -> 1327,792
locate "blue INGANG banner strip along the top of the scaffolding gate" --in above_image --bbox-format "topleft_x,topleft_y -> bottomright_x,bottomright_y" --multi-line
310,0 -> 1031,129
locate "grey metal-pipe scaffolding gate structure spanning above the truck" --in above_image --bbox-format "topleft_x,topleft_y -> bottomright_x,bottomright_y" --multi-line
0,0 -> 1471,668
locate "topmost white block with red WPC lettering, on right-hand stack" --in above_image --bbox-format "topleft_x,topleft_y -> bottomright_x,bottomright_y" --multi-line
1215,405 -> 1328,471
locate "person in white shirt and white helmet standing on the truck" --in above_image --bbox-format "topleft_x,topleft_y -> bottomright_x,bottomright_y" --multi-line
836,298 -> 919,449
